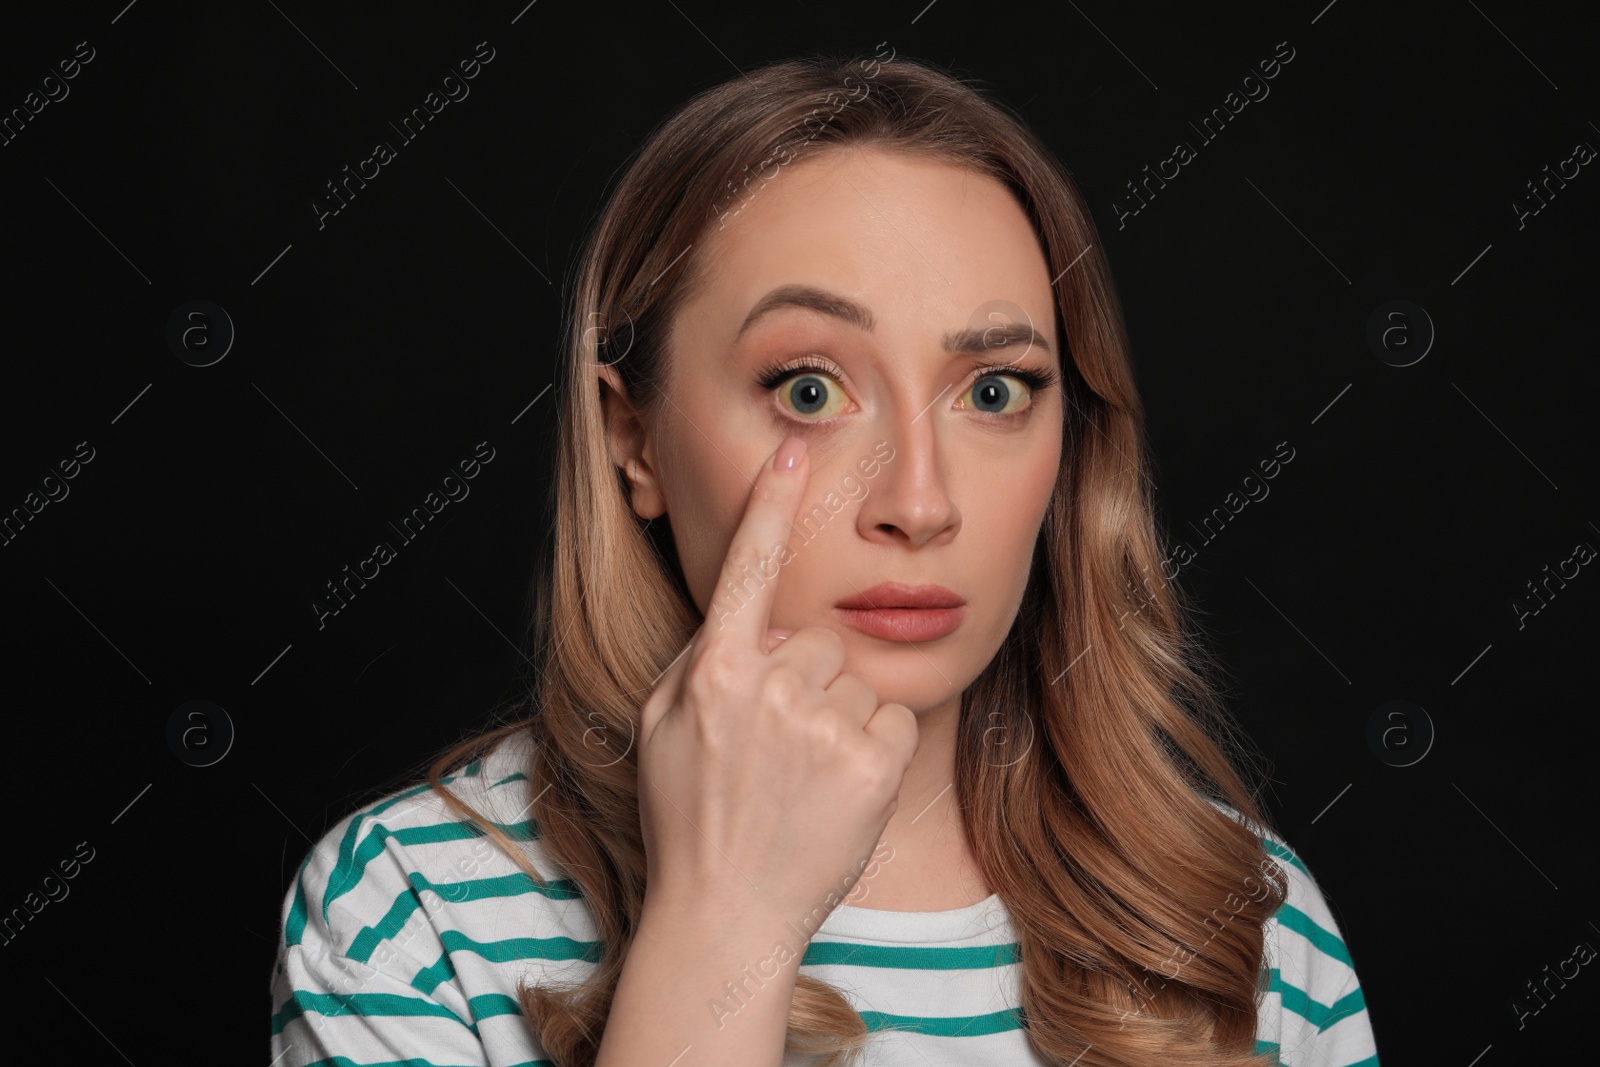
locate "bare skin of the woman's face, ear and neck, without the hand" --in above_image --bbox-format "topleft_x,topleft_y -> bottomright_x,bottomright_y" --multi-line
598,139 -> 1062,910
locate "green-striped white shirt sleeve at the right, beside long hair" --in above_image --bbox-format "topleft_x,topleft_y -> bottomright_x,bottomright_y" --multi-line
1256,837 -> 1378,1067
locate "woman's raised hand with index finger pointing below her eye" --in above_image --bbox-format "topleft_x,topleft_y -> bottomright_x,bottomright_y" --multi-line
638,438 -> 917,925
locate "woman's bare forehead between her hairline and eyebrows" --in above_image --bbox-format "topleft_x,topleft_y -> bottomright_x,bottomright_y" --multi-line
680,147 -> 1054,348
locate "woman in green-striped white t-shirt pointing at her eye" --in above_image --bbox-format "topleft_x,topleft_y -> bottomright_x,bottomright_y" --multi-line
272,53 -> 1378,1067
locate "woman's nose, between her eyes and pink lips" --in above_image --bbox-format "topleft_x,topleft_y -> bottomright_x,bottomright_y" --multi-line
856,397 -> 962,549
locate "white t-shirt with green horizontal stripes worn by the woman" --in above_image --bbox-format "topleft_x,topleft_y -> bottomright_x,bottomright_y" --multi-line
270,736 -> 1378,1067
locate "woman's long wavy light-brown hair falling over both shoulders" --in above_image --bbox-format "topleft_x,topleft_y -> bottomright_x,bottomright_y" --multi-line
427,47 -> 1285,1067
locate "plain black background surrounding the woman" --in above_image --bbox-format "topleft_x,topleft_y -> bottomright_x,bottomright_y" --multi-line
0,0 -> 1600,1067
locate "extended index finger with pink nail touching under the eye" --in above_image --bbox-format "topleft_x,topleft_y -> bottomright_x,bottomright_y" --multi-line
701,437 -> 811,643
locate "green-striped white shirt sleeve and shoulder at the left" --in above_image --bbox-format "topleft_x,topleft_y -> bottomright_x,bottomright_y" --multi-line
270,764 -> 563,1067
